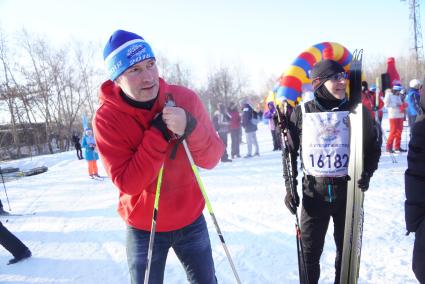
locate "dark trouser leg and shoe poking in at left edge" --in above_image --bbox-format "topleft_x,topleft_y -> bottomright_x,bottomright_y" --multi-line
0,222 -> 31,265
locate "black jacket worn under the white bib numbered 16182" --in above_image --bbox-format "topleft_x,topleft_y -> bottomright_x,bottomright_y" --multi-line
283,99 -> 382,201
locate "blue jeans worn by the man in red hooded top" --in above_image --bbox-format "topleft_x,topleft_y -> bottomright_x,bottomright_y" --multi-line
127,215 -> 217,284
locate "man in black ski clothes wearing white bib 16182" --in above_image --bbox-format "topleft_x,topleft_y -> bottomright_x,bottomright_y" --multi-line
283,59 -> 382,284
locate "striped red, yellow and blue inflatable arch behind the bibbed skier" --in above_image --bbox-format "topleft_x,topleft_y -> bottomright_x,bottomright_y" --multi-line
266,42 -> 353,106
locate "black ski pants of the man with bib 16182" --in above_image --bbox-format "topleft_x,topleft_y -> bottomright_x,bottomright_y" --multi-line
301,195 -> 346,284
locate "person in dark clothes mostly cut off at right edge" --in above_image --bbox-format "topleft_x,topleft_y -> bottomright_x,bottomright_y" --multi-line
404,90 -> 425,283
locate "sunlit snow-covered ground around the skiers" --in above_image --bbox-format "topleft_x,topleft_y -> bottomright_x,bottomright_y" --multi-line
0,116 -> 417,284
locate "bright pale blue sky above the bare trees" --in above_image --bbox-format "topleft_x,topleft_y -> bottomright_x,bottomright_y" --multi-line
0,0 -> 425,91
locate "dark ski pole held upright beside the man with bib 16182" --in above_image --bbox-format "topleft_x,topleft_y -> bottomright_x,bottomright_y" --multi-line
276,106 -> 309,283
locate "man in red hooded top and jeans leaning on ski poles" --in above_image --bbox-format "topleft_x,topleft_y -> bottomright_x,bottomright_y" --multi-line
94,30 -> 224,283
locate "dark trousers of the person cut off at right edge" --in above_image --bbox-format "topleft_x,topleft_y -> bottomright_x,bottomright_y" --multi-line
412,221 -> 425,283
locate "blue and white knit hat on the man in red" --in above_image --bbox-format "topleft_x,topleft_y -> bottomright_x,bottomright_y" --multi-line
103,30 -> 155,81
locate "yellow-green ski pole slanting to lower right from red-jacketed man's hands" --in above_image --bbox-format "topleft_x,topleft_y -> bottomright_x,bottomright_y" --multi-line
182,140 -> 241,284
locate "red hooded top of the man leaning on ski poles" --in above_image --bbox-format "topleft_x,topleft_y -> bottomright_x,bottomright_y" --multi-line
94,79 -> 224,232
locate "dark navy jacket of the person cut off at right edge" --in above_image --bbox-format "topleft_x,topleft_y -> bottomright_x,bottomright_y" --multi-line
404,106 -> 425,232
